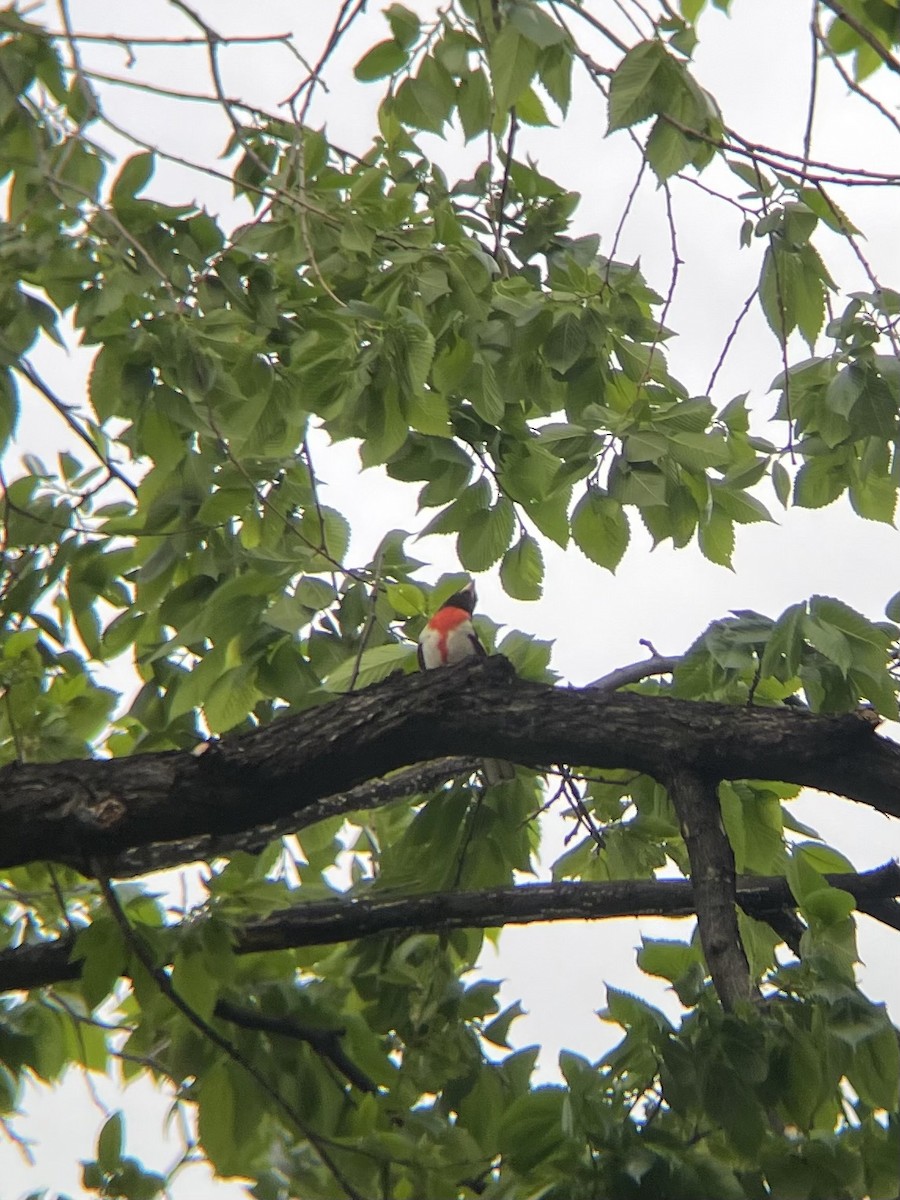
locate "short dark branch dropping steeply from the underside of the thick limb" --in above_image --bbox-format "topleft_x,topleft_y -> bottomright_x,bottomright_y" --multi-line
666,769 -> 754,1012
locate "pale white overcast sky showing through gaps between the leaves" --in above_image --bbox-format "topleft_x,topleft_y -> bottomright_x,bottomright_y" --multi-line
0,0 -> 900,1200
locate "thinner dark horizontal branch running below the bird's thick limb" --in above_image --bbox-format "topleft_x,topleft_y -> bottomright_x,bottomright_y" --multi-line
0,863 -> 900,992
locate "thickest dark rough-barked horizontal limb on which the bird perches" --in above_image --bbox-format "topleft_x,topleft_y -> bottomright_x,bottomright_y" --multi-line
0,658 -> 900,871
